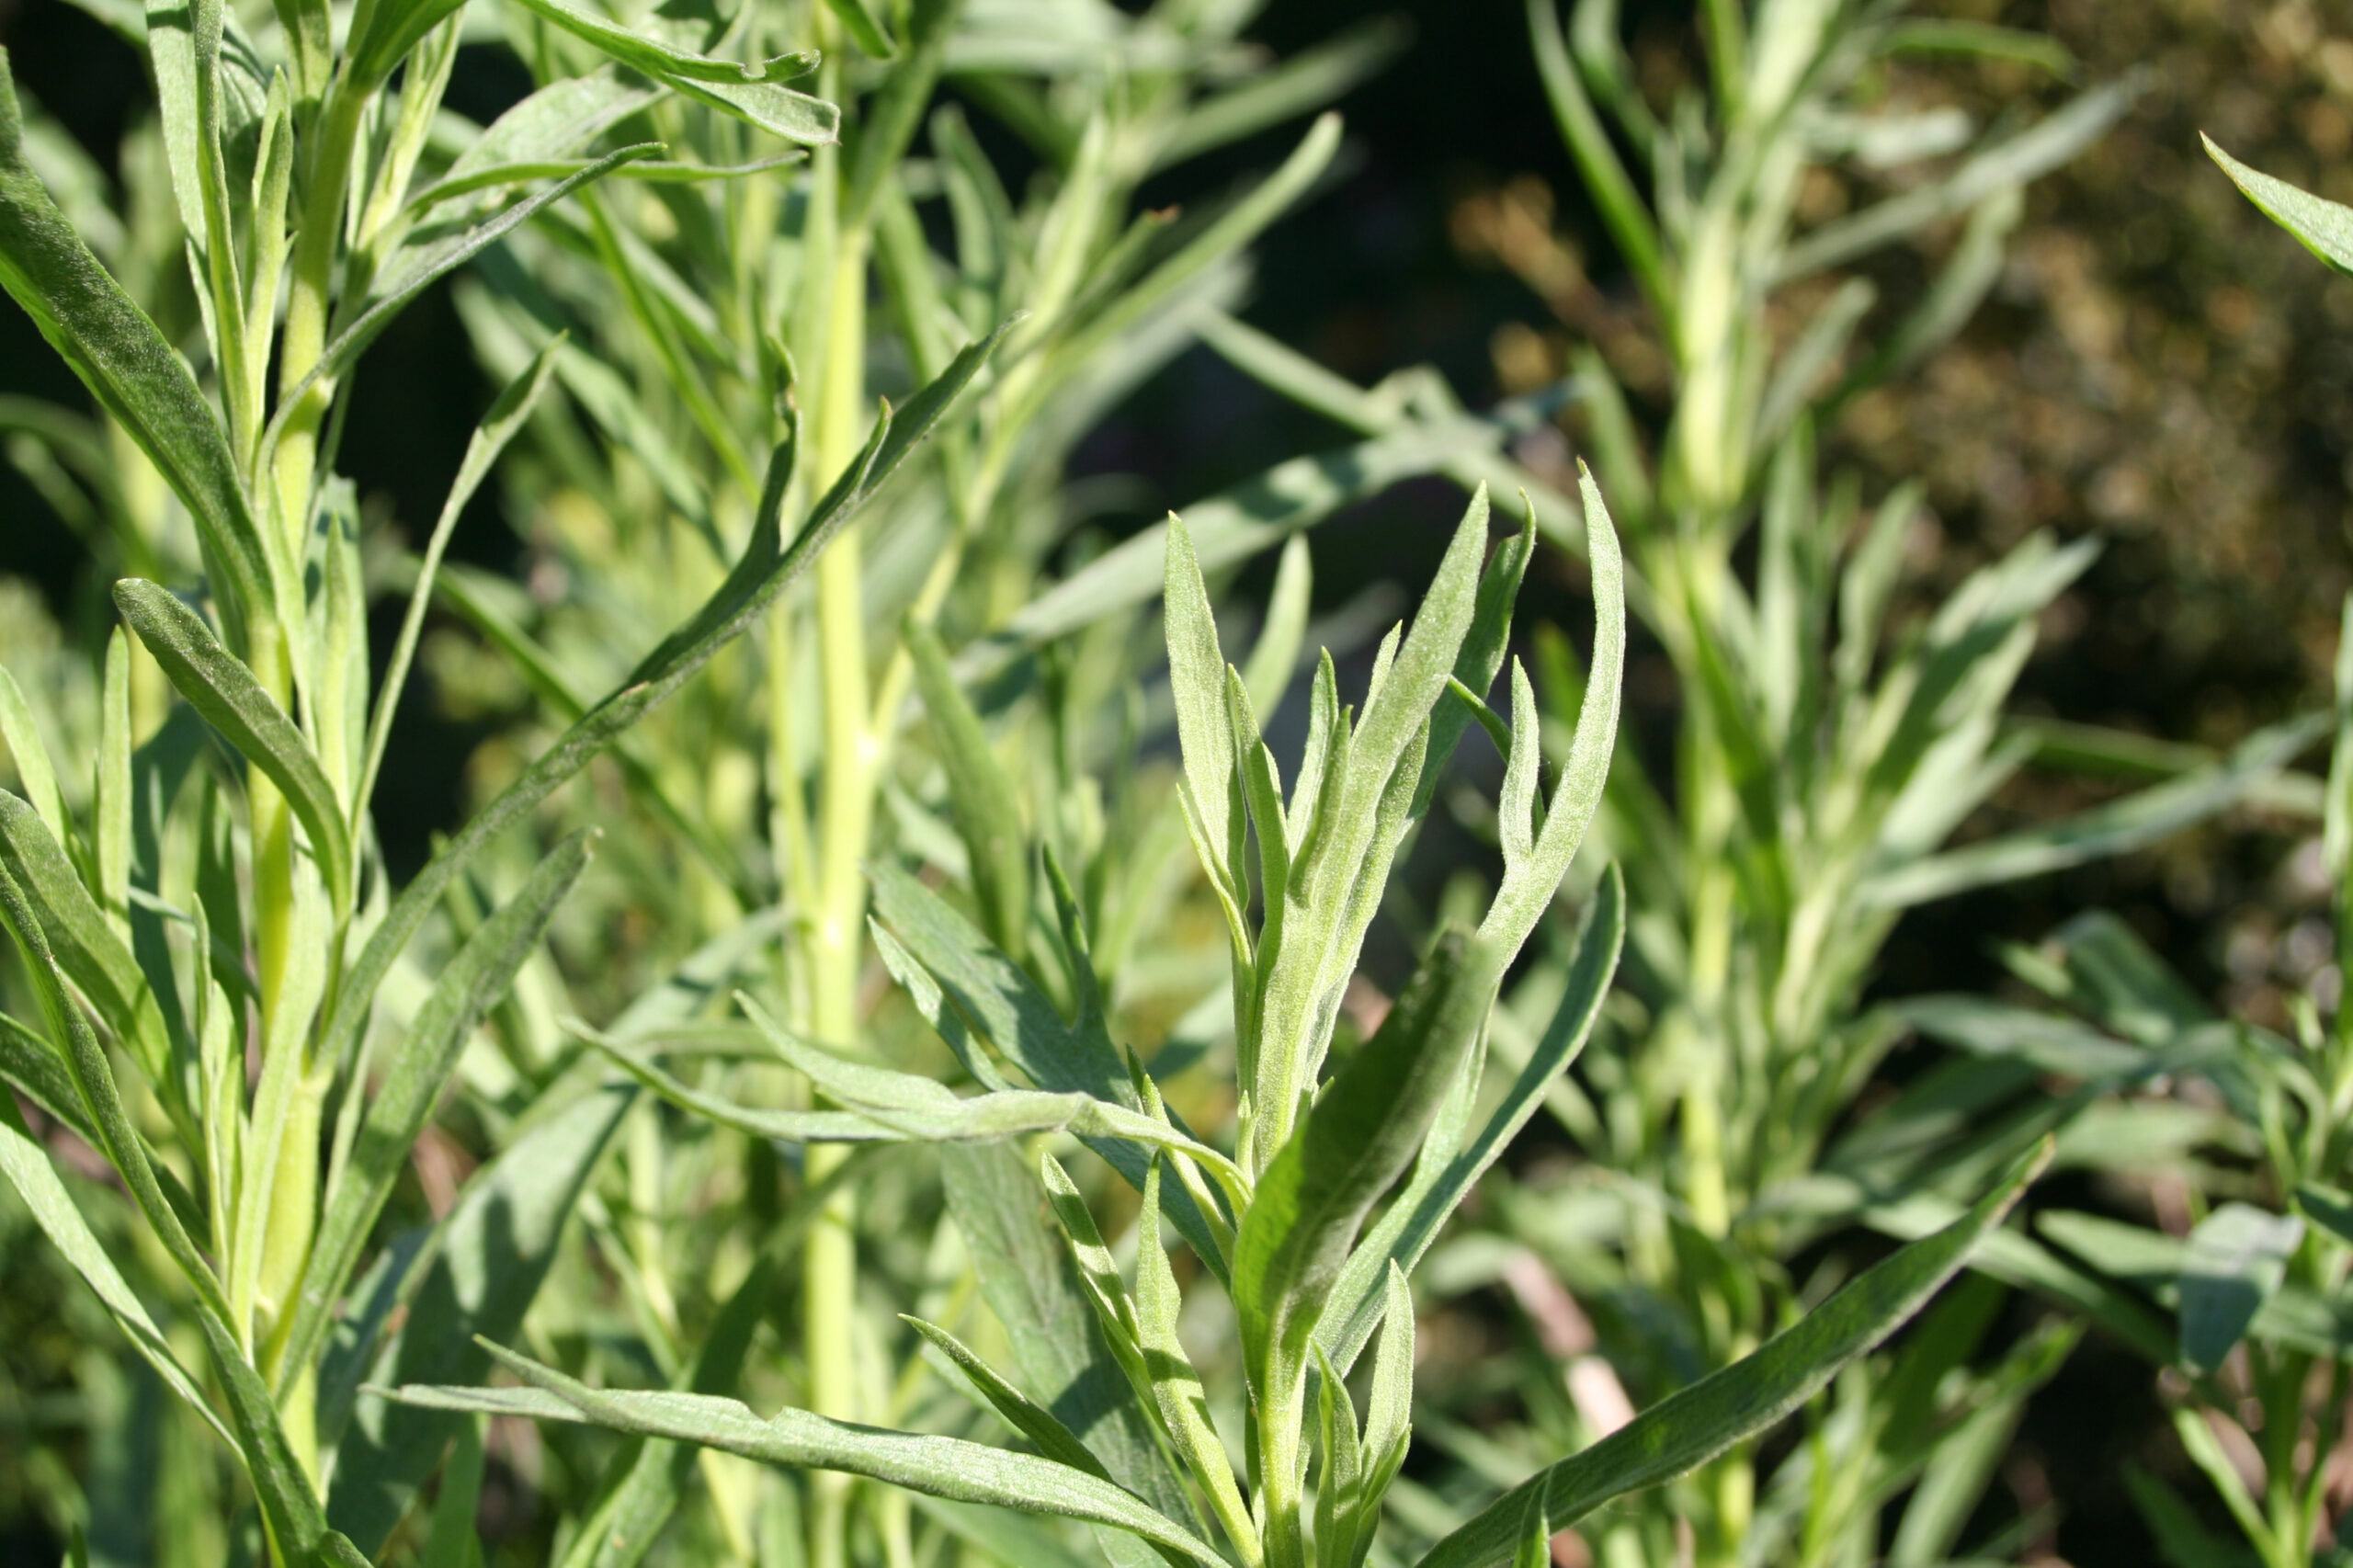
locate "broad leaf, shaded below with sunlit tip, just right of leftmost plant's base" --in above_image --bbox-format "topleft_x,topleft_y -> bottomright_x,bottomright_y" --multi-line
327,1087 -> 635,1554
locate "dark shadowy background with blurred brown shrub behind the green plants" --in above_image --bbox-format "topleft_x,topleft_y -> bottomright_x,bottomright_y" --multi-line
14,0 -> 2353,1565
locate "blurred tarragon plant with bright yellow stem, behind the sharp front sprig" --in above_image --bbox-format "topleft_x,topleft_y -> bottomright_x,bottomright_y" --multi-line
385,3 -> 1492,1561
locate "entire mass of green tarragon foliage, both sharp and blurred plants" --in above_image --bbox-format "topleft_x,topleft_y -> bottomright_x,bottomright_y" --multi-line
0,0 -> 2353,1568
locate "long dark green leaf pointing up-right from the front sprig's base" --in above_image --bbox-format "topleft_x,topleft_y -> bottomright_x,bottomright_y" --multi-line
1416,1142 -> 2050,1568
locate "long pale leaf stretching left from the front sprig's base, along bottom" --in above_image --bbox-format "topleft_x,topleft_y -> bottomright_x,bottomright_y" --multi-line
395,1342 -> 1226,1568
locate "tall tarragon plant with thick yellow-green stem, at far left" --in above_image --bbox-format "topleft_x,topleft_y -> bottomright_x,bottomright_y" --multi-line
0,0 -> 1021,1563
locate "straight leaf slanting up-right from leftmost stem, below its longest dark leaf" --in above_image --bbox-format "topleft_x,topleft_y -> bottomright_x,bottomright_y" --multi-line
282,829 -> 597,1378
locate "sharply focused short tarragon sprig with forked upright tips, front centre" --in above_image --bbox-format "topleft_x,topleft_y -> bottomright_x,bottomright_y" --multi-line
398,481 -> 2042,1568
